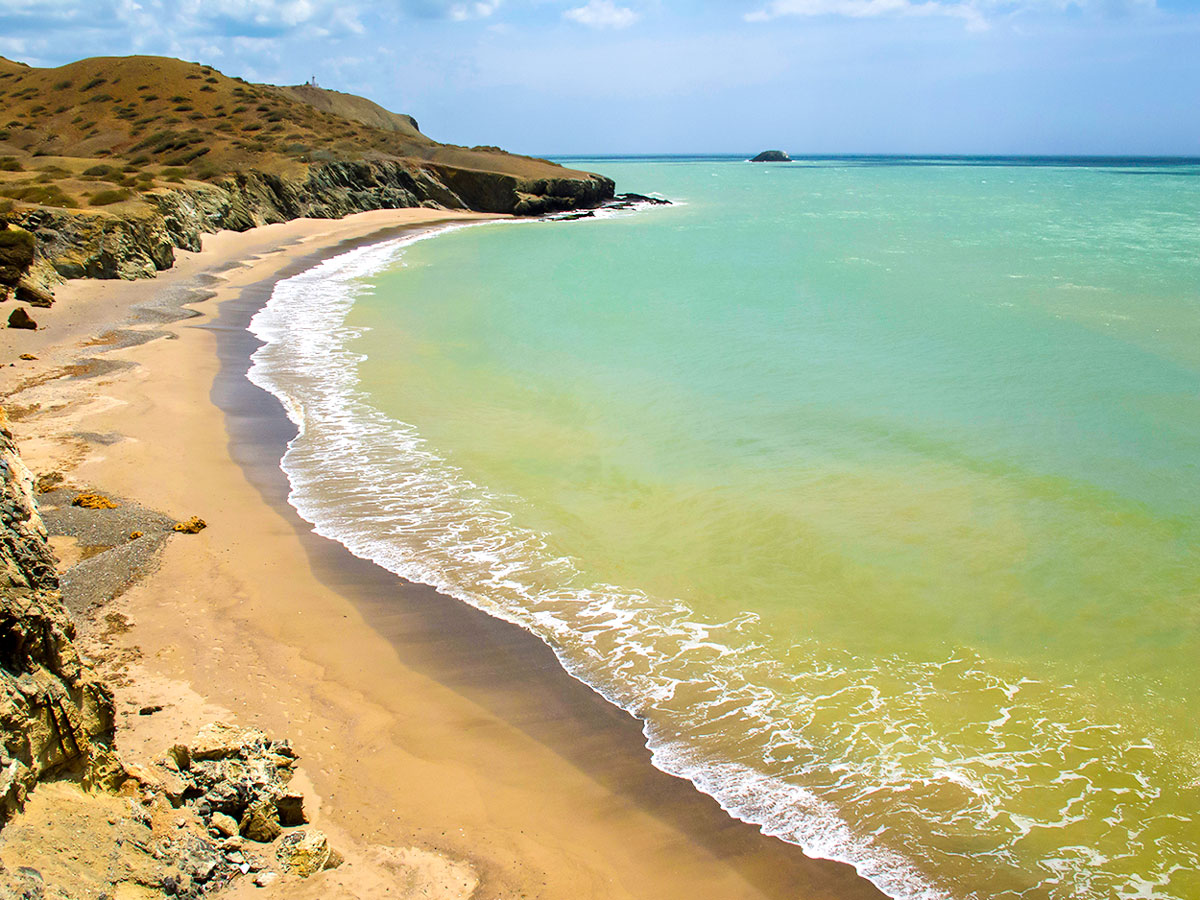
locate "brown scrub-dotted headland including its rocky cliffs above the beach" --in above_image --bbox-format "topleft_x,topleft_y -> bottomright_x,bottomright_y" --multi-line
0,56 -> 613,285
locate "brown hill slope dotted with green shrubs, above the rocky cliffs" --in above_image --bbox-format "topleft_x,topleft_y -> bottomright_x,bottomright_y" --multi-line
0,56 -> 585,212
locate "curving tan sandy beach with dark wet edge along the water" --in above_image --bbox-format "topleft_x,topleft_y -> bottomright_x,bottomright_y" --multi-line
5,211 -> 882,899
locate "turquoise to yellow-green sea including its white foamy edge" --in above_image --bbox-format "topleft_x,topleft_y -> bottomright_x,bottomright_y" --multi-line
251,158 -> 1200,900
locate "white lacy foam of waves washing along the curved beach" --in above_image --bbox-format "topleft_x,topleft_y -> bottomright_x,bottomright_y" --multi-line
248,226 -> 1190,900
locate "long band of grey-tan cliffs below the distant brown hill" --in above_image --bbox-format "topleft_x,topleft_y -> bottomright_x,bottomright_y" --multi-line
7,160 -> 614,281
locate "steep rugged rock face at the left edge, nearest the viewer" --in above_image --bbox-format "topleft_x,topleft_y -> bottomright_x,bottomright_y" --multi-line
0,422 -> 124,826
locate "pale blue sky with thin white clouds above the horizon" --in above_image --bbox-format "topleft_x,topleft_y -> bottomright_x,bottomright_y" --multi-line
0,0 -> 1200,156
